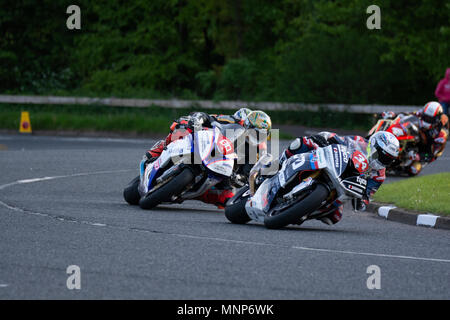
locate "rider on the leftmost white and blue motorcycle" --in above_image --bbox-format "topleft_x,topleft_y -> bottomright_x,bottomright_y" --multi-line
145,108 -> 272,209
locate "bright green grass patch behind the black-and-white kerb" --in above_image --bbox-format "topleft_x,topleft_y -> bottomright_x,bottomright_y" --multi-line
374,172 -> 450,215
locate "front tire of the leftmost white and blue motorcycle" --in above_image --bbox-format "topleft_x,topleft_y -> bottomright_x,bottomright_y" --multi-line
139,168 -> 194,210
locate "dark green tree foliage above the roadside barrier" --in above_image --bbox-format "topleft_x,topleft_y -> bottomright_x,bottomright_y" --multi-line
0,0 -> 450,104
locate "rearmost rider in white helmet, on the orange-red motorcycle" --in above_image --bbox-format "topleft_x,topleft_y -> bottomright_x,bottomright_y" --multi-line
382,101 -> 449,175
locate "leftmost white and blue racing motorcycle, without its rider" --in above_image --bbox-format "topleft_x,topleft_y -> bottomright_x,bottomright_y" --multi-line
123,123 -> 250,209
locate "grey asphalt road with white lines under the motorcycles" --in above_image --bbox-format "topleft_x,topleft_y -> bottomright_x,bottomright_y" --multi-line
0,135 -> 450,299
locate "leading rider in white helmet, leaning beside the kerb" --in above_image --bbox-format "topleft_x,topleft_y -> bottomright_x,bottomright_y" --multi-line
279,131 -> 399,225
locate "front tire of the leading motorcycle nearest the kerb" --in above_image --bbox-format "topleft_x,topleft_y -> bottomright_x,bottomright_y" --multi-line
264,183 -> 329,229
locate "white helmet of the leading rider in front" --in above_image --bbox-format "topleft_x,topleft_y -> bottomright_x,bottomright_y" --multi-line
367,131 -> 400,170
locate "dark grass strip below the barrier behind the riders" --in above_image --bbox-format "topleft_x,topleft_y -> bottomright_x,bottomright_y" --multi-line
0,104 -> 372,139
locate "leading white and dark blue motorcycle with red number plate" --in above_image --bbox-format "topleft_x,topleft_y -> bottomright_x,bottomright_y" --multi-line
225,144 -> 369,229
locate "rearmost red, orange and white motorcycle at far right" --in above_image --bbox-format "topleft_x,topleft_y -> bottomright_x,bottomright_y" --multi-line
368,115 -> 424,175
